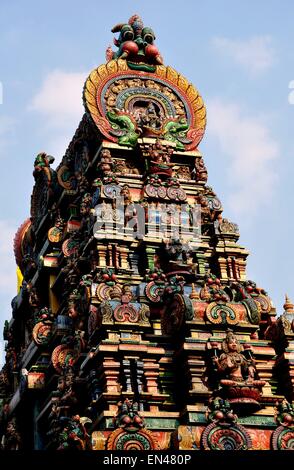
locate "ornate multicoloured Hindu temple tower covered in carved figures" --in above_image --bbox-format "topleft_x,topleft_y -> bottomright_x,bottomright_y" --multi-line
0,15 -> 294,450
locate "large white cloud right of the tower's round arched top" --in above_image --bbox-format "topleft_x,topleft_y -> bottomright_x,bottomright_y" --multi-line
207,99 -> 280,219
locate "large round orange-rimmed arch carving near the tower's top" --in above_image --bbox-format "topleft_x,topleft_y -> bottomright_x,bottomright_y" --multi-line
84,59 -> 206,150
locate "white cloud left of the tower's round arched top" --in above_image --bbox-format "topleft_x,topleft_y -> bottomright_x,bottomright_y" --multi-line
29,70 -> 87,163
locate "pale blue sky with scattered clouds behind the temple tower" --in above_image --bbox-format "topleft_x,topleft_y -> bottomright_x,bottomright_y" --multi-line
0,0 -> 294,360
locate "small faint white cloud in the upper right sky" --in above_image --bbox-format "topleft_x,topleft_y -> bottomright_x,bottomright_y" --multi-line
212,36 -> 275,75
